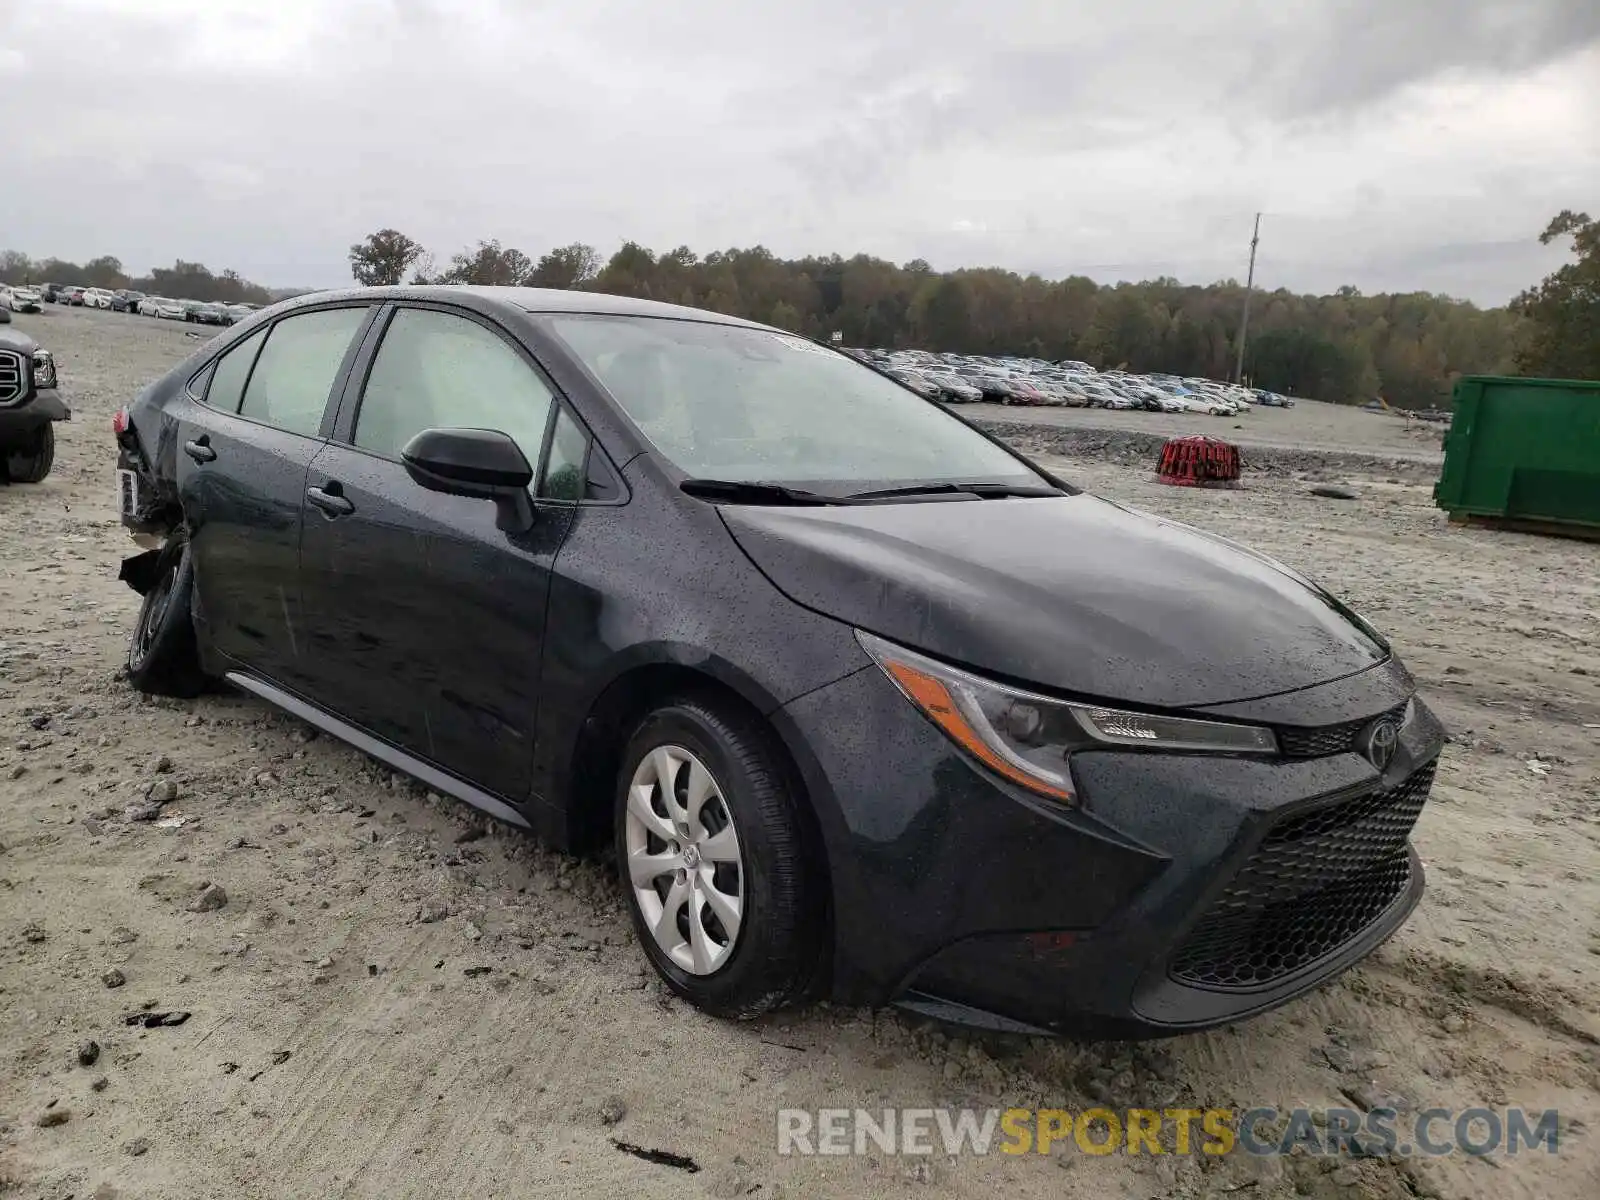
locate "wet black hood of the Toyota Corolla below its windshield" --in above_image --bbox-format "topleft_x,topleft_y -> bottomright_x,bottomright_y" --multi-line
722,494 -> 1389,709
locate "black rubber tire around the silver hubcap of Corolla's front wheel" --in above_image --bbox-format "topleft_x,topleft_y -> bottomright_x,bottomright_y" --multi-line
614,696 -> 826,1021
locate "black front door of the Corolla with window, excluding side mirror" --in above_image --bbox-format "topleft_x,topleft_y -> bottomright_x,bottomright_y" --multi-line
301,307 -> 571,802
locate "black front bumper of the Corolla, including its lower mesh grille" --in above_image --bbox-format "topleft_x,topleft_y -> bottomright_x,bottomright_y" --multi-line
779,652 -> 1443,1037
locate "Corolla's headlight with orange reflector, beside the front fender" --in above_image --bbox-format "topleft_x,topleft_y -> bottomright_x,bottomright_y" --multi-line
856,629 -> 1278,803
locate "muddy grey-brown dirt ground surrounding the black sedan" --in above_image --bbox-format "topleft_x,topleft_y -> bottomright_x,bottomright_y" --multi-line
0,309 -> 1600,1200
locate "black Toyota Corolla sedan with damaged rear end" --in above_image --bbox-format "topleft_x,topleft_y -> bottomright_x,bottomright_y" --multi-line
117,288 -> 1443,1034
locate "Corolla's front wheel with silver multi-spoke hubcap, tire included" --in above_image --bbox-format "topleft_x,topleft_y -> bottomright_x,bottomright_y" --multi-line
604,696 -> 824,1021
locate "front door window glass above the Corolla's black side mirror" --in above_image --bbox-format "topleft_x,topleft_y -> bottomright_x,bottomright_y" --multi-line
354,309 -> 555,467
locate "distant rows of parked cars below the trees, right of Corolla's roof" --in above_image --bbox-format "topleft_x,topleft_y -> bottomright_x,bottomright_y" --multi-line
851,349 -> 1294,416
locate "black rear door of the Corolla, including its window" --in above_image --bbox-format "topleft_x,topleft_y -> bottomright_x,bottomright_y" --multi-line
178,306 -> 373,690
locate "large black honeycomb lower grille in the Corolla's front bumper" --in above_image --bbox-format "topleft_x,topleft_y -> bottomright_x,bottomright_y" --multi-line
1170,763 -> 1435,992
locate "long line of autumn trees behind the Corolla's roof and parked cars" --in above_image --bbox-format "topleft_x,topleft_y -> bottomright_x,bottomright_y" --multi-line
350,227 -> 1600,408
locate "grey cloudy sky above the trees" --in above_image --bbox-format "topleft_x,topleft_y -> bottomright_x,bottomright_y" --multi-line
0,0 -> 1600,304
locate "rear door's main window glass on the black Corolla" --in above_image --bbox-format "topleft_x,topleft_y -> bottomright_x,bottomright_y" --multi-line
238,307 -> 366,437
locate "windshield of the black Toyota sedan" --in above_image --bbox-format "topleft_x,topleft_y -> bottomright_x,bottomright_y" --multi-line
547,314 -> 1048,493
